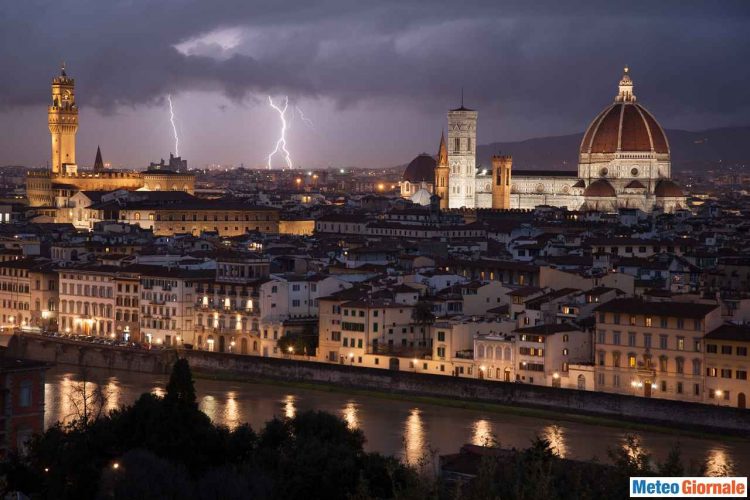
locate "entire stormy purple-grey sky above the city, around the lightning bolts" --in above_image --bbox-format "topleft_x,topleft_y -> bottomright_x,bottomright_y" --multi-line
0,0 -> 750,168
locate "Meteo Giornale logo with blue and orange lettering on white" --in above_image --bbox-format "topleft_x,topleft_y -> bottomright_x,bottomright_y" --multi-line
630,477 -> 747,498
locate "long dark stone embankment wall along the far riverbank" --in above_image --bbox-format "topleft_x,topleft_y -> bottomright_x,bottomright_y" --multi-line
9,336 -> 750,435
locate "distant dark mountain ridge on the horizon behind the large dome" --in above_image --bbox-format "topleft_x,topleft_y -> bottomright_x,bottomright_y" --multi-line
477,126 -> 750,170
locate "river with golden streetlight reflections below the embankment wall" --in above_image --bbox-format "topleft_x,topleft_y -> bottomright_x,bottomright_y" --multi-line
45,365 -> 750,475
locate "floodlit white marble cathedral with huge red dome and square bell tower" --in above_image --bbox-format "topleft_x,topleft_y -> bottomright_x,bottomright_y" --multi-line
402,68 -> 686,212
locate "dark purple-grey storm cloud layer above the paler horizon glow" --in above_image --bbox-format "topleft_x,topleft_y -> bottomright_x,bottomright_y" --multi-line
0,0 -> 750,128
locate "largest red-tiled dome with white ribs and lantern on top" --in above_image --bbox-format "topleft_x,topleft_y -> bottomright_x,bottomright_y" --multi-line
581,68 -> 669,154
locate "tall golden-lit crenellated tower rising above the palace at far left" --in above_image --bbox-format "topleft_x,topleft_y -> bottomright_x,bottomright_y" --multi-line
47,63 -> 78,175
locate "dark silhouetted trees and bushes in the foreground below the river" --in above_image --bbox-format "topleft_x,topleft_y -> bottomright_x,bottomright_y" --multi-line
2,360 -> 736,500
